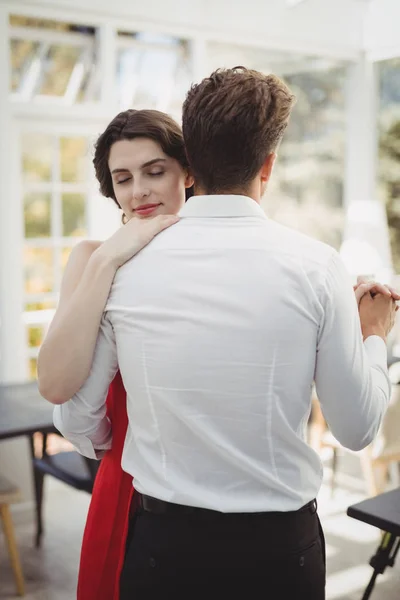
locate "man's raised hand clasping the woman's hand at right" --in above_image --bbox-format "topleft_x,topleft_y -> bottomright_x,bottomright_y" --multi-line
359,293 -> 398,342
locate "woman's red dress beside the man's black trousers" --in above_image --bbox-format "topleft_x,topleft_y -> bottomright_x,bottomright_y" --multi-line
77,372 -> 133,600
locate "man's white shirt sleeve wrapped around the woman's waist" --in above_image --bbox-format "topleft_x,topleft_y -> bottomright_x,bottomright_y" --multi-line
53,313 -> 118,459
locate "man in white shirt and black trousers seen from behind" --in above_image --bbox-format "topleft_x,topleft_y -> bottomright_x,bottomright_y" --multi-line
55,68 -> 395,600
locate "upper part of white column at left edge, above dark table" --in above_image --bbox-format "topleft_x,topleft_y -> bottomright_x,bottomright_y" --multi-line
0,5 -> 27,382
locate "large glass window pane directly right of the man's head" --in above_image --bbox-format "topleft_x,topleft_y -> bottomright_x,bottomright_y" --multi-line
265,66 -> 345,249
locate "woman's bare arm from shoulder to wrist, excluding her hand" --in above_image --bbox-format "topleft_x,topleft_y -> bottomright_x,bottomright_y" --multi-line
38,242 -> 116,404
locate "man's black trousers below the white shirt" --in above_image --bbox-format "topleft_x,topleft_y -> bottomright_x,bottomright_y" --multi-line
120,503 -> 325,600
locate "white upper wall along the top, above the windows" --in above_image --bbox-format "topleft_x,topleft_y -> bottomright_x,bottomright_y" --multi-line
8,0 -> 366,58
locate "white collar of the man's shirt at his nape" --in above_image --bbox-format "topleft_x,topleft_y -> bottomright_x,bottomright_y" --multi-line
179,194 -> 267,219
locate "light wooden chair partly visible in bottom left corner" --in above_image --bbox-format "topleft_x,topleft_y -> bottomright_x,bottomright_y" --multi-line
0,475 -> 25,596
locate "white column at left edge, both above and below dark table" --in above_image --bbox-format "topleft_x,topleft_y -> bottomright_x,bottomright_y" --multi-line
0,4 -> 33,508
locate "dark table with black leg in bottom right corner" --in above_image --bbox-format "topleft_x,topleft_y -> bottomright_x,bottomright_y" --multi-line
347,488 -> 400,600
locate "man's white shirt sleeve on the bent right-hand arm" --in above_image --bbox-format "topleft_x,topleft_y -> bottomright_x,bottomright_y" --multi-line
315,252 -> 390,450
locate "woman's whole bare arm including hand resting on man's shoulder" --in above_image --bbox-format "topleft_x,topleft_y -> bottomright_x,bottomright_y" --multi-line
38,215 -> 178,404
